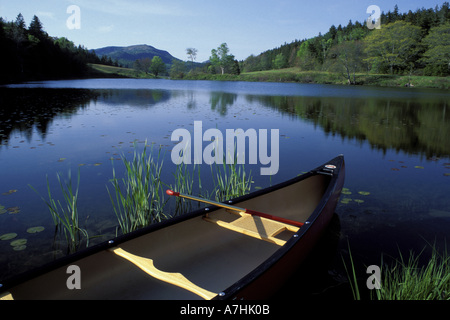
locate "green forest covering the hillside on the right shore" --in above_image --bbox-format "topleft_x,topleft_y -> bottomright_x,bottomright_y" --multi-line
240,2 -> 450,82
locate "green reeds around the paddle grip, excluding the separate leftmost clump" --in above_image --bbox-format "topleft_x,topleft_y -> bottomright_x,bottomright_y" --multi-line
108,147 -> 252,233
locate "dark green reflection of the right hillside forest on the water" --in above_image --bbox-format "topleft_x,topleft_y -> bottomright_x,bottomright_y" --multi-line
248,96 -> 450,157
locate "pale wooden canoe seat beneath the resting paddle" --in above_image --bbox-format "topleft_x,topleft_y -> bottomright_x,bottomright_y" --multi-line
203,210 -> 299,246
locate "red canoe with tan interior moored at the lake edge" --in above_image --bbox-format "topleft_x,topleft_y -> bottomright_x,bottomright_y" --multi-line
0,155 -> 345,300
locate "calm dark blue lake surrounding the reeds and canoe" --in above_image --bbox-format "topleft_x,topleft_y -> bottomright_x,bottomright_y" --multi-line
0,79 -> 450,296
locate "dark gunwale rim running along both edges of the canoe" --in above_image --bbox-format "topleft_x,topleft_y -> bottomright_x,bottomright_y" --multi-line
0,155 -> 344,300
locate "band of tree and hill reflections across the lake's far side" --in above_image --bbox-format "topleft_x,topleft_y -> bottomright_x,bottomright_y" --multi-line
0,88 -> 450,157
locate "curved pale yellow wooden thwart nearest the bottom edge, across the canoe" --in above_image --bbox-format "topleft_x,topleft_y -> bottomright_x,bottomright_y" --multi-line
109,247 -> 217,300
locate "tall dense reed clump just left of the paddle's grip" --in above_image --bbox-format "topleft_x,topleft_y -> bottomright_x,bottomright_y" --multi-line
107,146 -> 167,233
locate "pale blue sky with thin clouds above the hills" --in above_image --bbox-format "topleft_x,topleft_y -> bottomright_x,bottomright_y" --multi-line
0,0 -> 445,62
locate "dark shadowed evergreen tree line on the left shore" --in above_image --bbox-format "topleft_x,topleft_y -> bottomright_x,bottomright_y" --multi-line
0,13 -> 117,82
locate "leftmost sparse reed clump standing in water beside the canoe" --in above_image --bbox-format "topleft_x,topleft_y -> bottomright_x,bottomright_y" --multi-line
30,171 -> 89,253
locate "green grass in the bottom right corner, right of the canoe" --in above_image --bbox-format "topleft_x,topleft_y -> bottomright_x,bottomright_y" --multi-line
343,242 -> 450,300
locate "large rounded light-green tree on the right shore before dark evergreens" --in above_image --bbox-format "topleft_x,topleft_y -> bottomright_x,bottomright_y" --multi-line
364,21 -> 421,74
